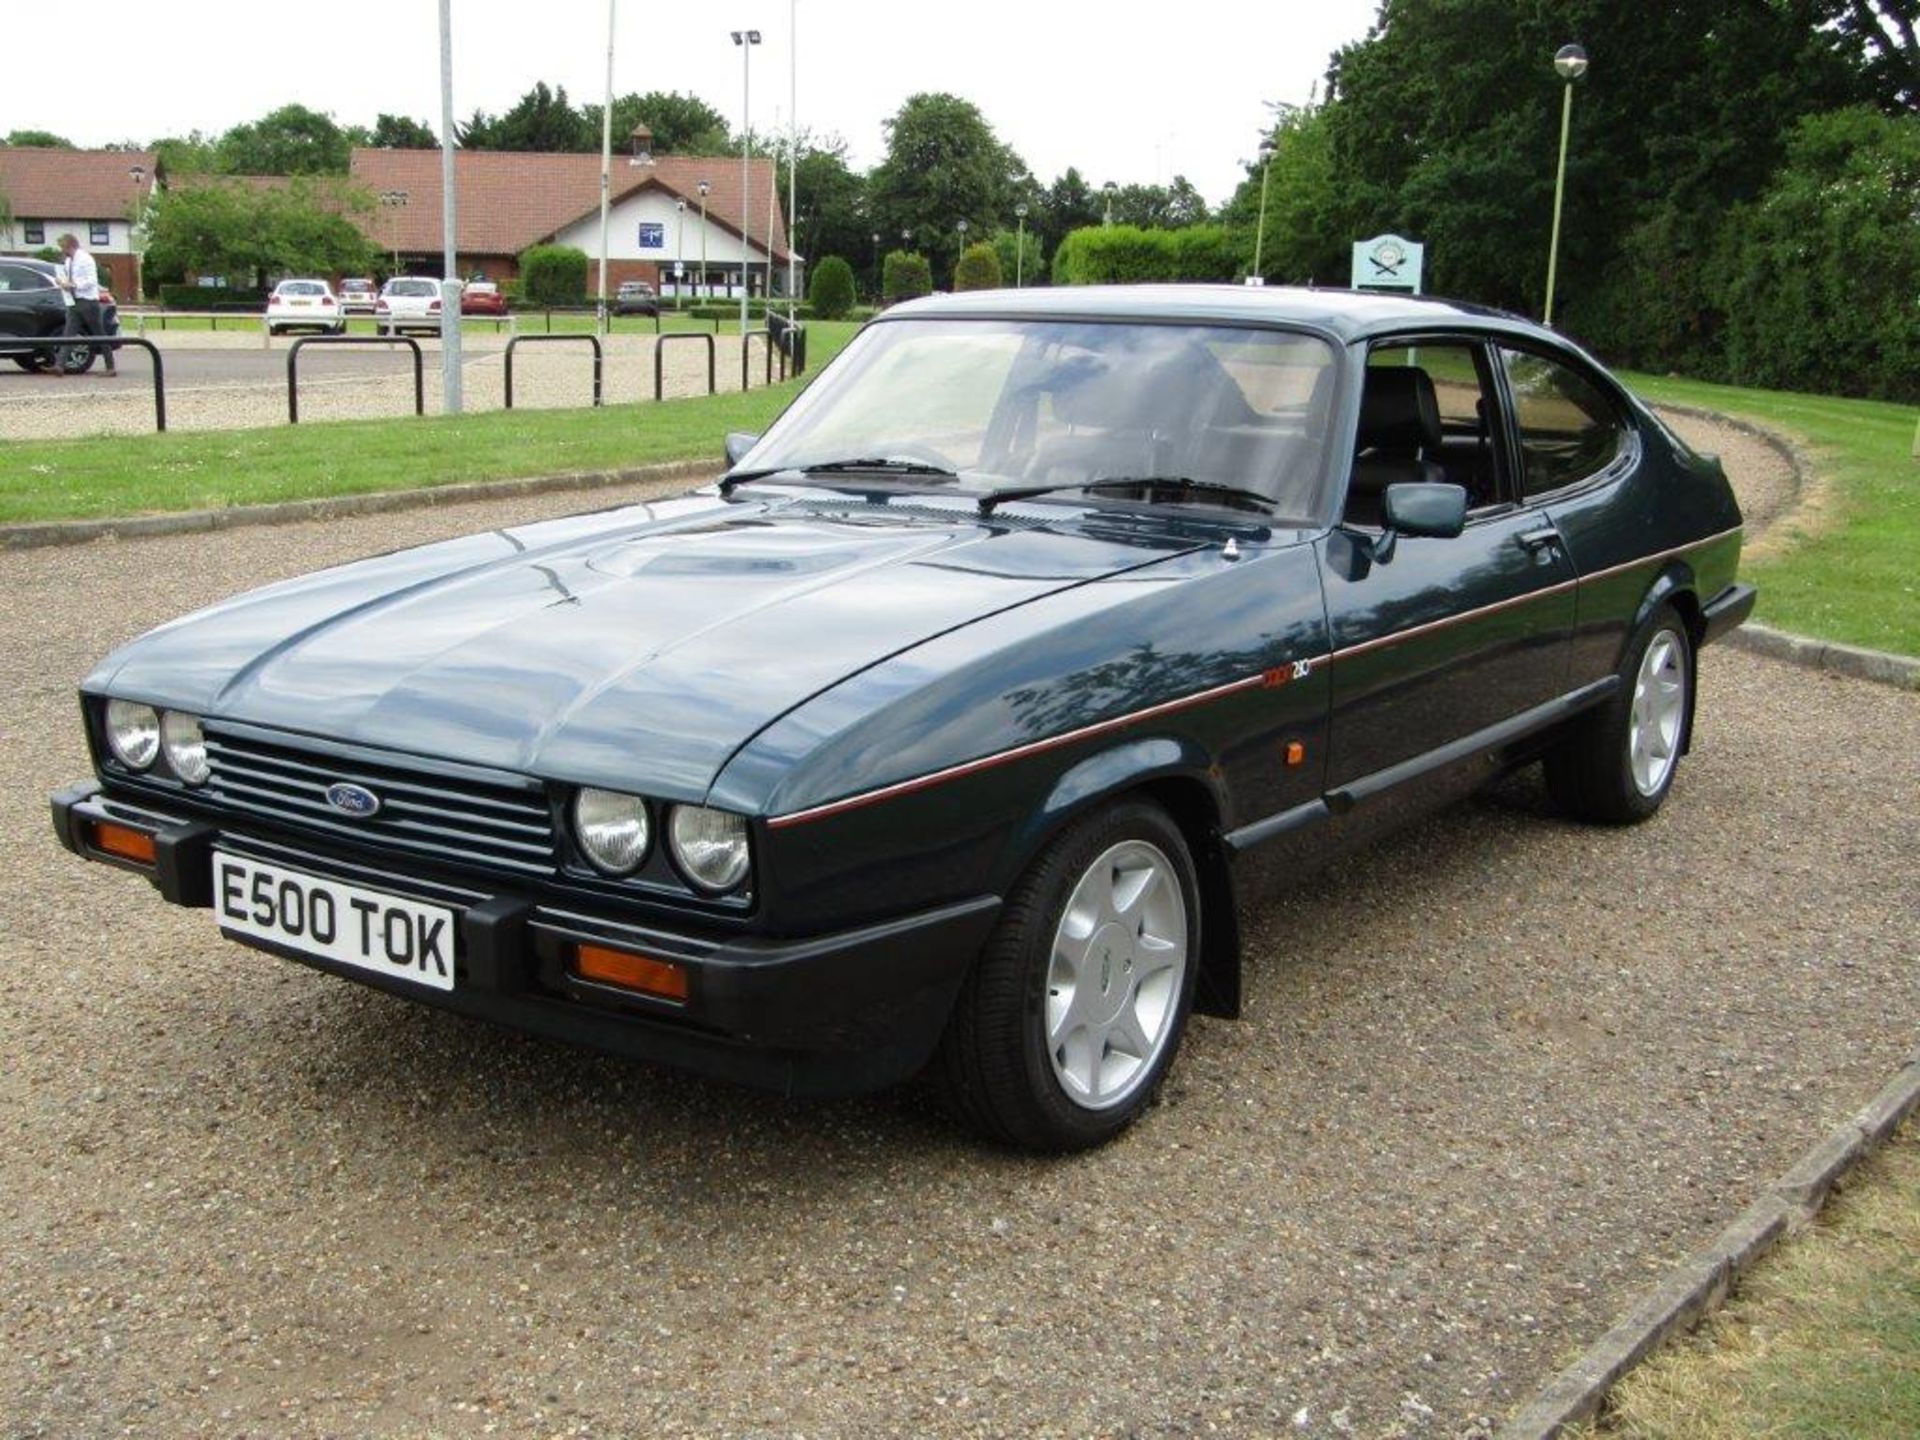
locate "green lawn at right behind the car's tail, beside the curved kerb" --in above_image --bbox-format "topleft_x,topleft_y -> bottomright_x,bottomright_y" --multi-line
1622,374 -> 1920,655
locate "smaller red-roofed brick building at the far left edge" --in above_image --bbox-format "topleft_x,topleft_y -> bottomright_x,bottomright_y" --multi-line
0,146 -> 159,300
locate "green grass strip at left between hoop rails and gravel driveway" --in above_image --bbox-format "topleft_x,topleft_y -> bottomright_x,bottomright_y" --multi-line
0,321 -> 858,522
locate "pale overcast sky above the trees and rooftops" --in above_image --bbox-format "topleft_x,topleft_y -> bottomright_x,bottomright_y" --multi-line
0,0 -> 1375,204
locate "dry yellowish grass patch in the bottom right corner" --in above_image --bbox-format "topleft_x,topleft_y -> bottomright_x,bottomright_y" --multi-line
1576,1125 -> 1920,1440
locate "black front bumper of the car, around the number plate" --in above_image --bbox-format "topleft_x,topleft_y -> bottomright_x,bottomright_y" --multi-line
52,781 -> 1000,1096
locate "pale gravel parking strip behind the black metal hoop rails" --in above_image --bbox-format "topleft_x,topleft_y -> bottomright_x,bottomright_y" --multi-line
0,330 -> 780,440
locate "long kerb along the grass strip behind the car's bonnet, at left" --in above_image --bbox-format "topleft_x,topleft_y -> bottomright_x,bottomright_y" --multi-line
0,461 -> 726,549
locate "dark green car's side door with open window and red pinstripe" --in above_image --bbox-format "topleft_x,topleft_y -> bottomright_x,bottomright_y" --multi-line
1319,334 -> 1574,808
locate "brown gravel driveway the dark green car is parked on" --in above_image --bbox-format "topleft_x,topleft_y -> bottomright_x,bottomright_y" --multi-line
0,410 -> 1920,1440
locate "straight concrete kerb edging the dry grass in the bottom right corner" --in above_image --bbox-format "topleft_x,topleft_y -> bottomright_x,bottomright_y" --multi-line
1500,1050 -> 1920,1440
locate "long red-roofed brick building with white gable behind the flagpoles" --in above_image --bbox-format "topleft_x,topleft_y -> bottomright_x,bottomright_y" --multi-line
349,129 -> 806,296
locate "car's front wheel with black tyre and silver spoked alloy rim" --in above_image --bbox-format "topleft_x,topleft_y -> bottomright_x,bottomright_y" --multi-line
933,801 -> 1200,1152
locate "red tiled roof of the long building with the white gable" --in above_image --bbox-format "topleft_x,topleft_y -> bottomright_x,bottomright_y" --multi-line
349,148 -> 787,259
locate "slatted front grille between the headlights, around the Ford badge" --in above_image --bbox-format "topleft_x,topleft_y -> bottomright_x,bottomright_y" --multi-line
200,722 -> 555,874
